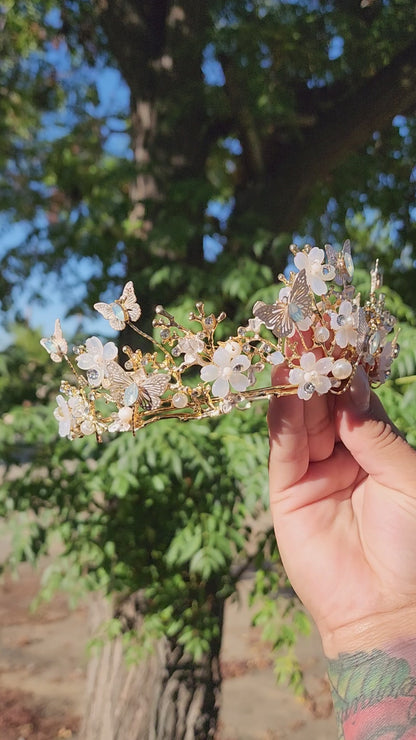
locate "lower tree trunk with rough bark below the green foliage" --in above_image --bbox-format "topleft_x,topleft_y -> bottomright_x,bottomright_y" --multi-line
80,596 -> 224,740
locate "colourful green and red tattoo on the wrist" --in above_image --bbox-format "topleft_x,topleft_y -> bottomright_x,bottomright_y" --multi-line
328,639 -> 416,740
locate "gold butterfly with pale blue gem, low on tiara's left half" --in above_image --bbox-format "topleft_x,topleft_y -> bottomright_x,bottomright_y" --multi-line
105,360 -> 170,411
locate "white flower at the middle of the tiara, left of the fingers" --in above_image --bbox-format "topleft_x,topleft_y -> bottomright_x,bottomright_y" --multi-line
201,341 -> 250,398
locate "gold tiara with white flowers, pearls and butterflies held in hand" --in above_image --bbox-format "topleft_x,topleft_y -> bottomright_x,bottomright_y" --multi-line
41,241 -> 399,441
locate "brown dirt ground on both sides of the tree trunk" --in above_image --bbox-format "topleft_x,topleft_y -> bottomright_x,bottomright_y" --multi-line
0,566 -> 336,740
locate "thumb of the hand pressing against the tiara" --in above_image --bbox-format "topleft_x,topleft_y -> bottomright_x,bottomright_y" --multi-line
335,367 -> 416,491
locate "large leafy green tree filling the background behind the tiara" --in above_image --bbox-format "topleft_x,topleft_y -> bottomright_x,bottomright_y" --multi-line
0,0 -> 416,740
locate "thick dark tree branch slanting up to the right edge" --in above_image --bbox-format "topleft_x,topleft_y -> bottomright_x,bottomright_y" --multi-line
262,41 -> 416,231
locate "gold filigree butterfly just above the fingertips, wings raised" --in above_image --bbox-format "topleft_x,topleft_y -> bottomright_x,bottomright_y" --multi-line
253,270 -> 313,337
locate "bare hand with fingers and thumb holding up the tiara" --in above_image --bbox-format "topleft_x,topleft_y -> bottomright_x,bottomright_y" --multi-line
269,368 -> 416,657
